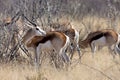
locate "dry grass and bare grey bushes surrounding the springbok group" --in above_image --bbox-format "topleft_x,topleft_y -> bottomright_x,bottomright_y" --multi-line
0,0 -> 120,80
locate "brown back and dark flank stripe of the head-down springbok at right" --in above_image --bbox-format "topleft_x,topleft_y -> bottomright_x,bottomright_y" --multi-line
80,29 -> 118,48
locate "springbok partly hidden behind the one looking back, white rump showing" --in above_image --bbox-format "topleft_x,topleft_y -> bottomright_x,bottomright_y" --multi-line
50,22 -> 81,59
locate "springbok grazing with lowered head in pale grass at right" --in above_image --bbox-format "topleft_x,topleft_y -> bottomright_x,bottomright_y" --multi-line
80,29 -> 119,57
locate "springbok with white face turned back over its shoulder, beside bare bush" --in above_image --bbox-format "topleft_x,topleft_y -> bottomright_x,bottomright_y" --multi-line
23,28 -> 70,68
